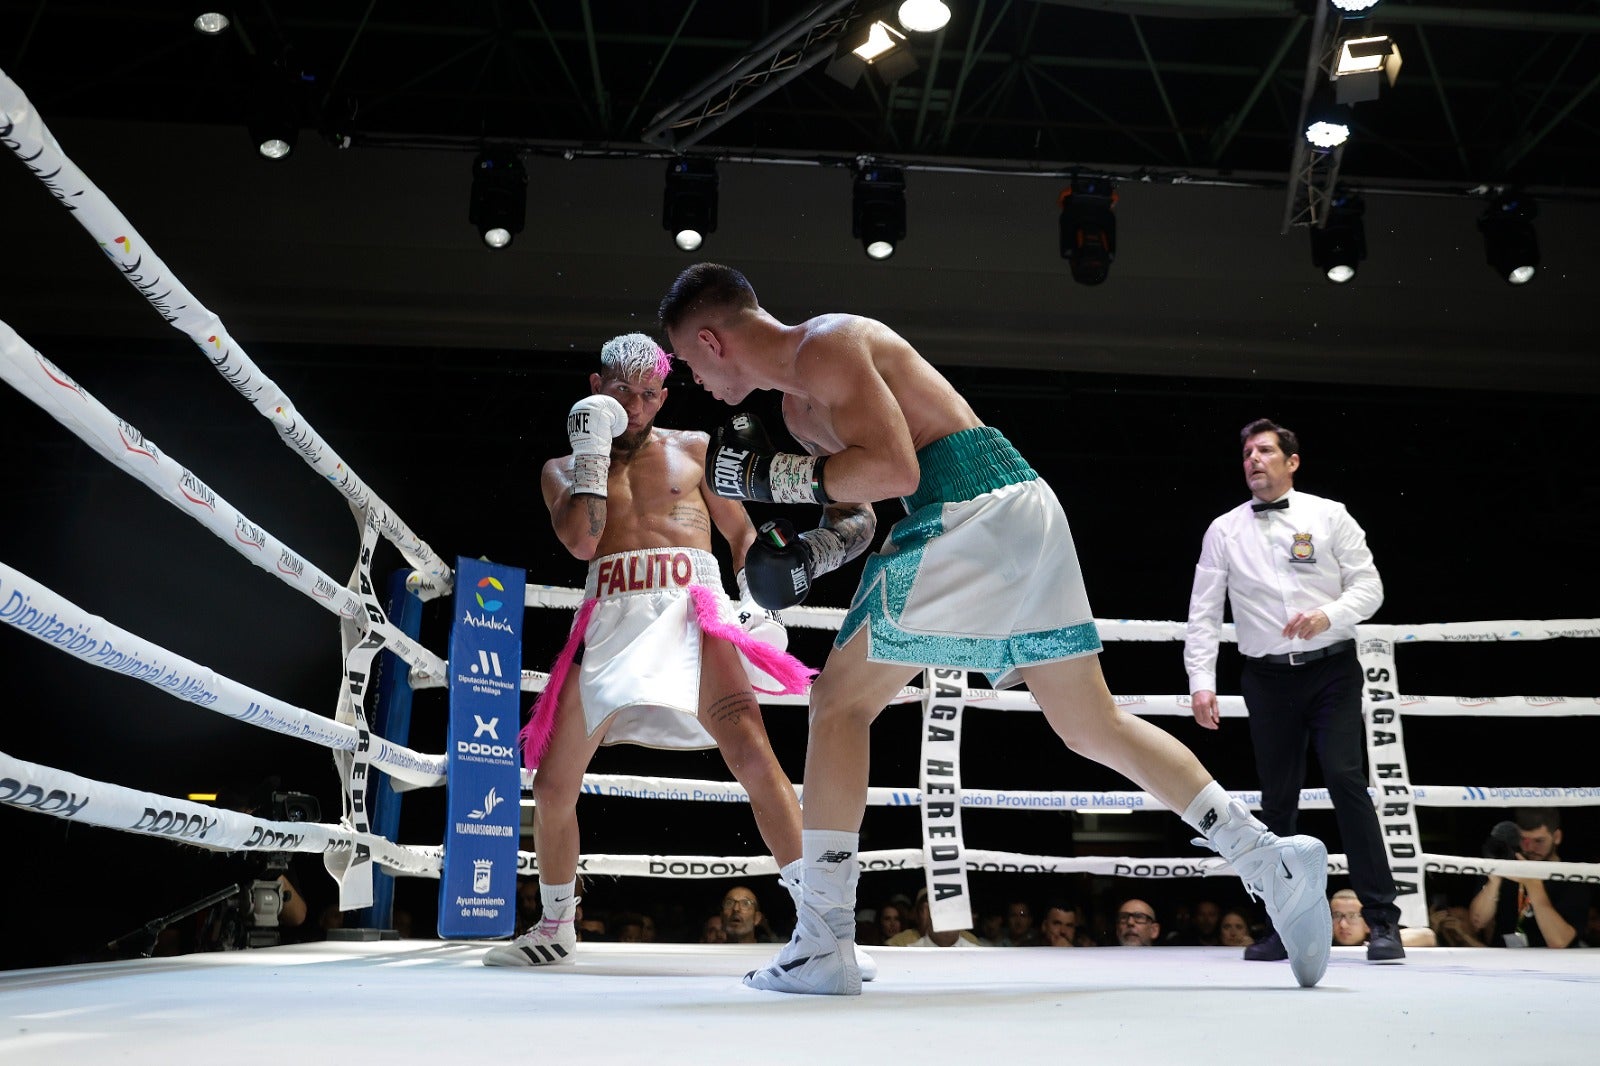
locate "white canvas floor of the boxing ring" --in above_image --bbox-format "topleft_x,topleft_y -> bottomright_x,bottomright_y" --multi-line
0,941 -> 1600,1066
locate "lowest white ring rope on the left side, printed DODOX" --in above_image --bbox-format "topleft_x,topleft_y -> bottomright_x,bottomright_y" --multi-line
0,742 -> 438,877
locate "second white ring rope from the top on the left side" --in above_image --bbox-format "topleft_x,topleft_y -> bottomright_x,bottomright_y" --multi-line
0,322 -> 445,674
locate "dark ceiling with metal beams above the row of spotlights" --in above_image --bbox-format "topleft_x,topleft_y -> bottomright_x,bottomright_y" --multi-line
9,0 -> 1600,190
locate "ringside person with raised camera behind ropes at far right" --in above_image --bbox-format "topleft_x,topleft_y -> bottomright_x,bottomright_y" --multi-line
1469,807 -> 1589,948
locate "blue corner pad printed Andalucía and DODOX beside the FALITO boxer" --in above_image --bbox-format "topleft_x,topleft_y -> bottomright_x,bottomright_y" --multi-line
438,557 -> 526,940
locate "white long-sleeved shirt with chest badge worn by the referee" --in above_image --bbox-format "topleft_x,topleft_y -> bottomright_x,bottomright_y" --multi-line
1184,488 -> 1384,691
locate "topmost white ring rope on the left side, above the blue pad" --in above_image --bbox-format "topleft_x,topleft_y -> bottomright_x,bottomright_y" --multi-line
0,70 -> 453,592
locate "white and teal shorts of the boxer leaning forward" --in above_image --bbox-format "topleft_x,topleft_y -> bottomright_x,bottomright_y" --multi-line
834,426 -> 1101,687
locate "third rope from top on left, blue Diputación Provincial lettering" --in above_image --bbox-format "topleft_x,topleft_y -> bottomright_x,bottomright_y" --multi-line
0,562 -> 446,786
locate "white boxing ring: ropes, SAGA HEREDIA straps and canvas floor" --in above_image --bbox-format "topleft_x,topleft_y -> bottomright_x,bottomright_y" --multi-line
0,64 -> 1600,1063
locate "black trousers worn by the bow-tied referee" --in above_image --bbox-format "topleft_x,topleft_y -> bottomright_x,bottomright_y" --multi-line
1240,651 -> 1400,925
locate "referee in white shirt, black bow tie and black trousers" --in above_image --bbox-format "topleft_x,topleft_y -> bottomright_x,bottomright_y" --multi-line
1184,418 -> 1405,962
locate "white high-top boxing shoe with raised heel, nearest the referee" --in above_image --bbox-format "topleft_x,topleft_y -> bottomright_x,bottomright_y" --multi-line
1229,832 -> 1333,988
